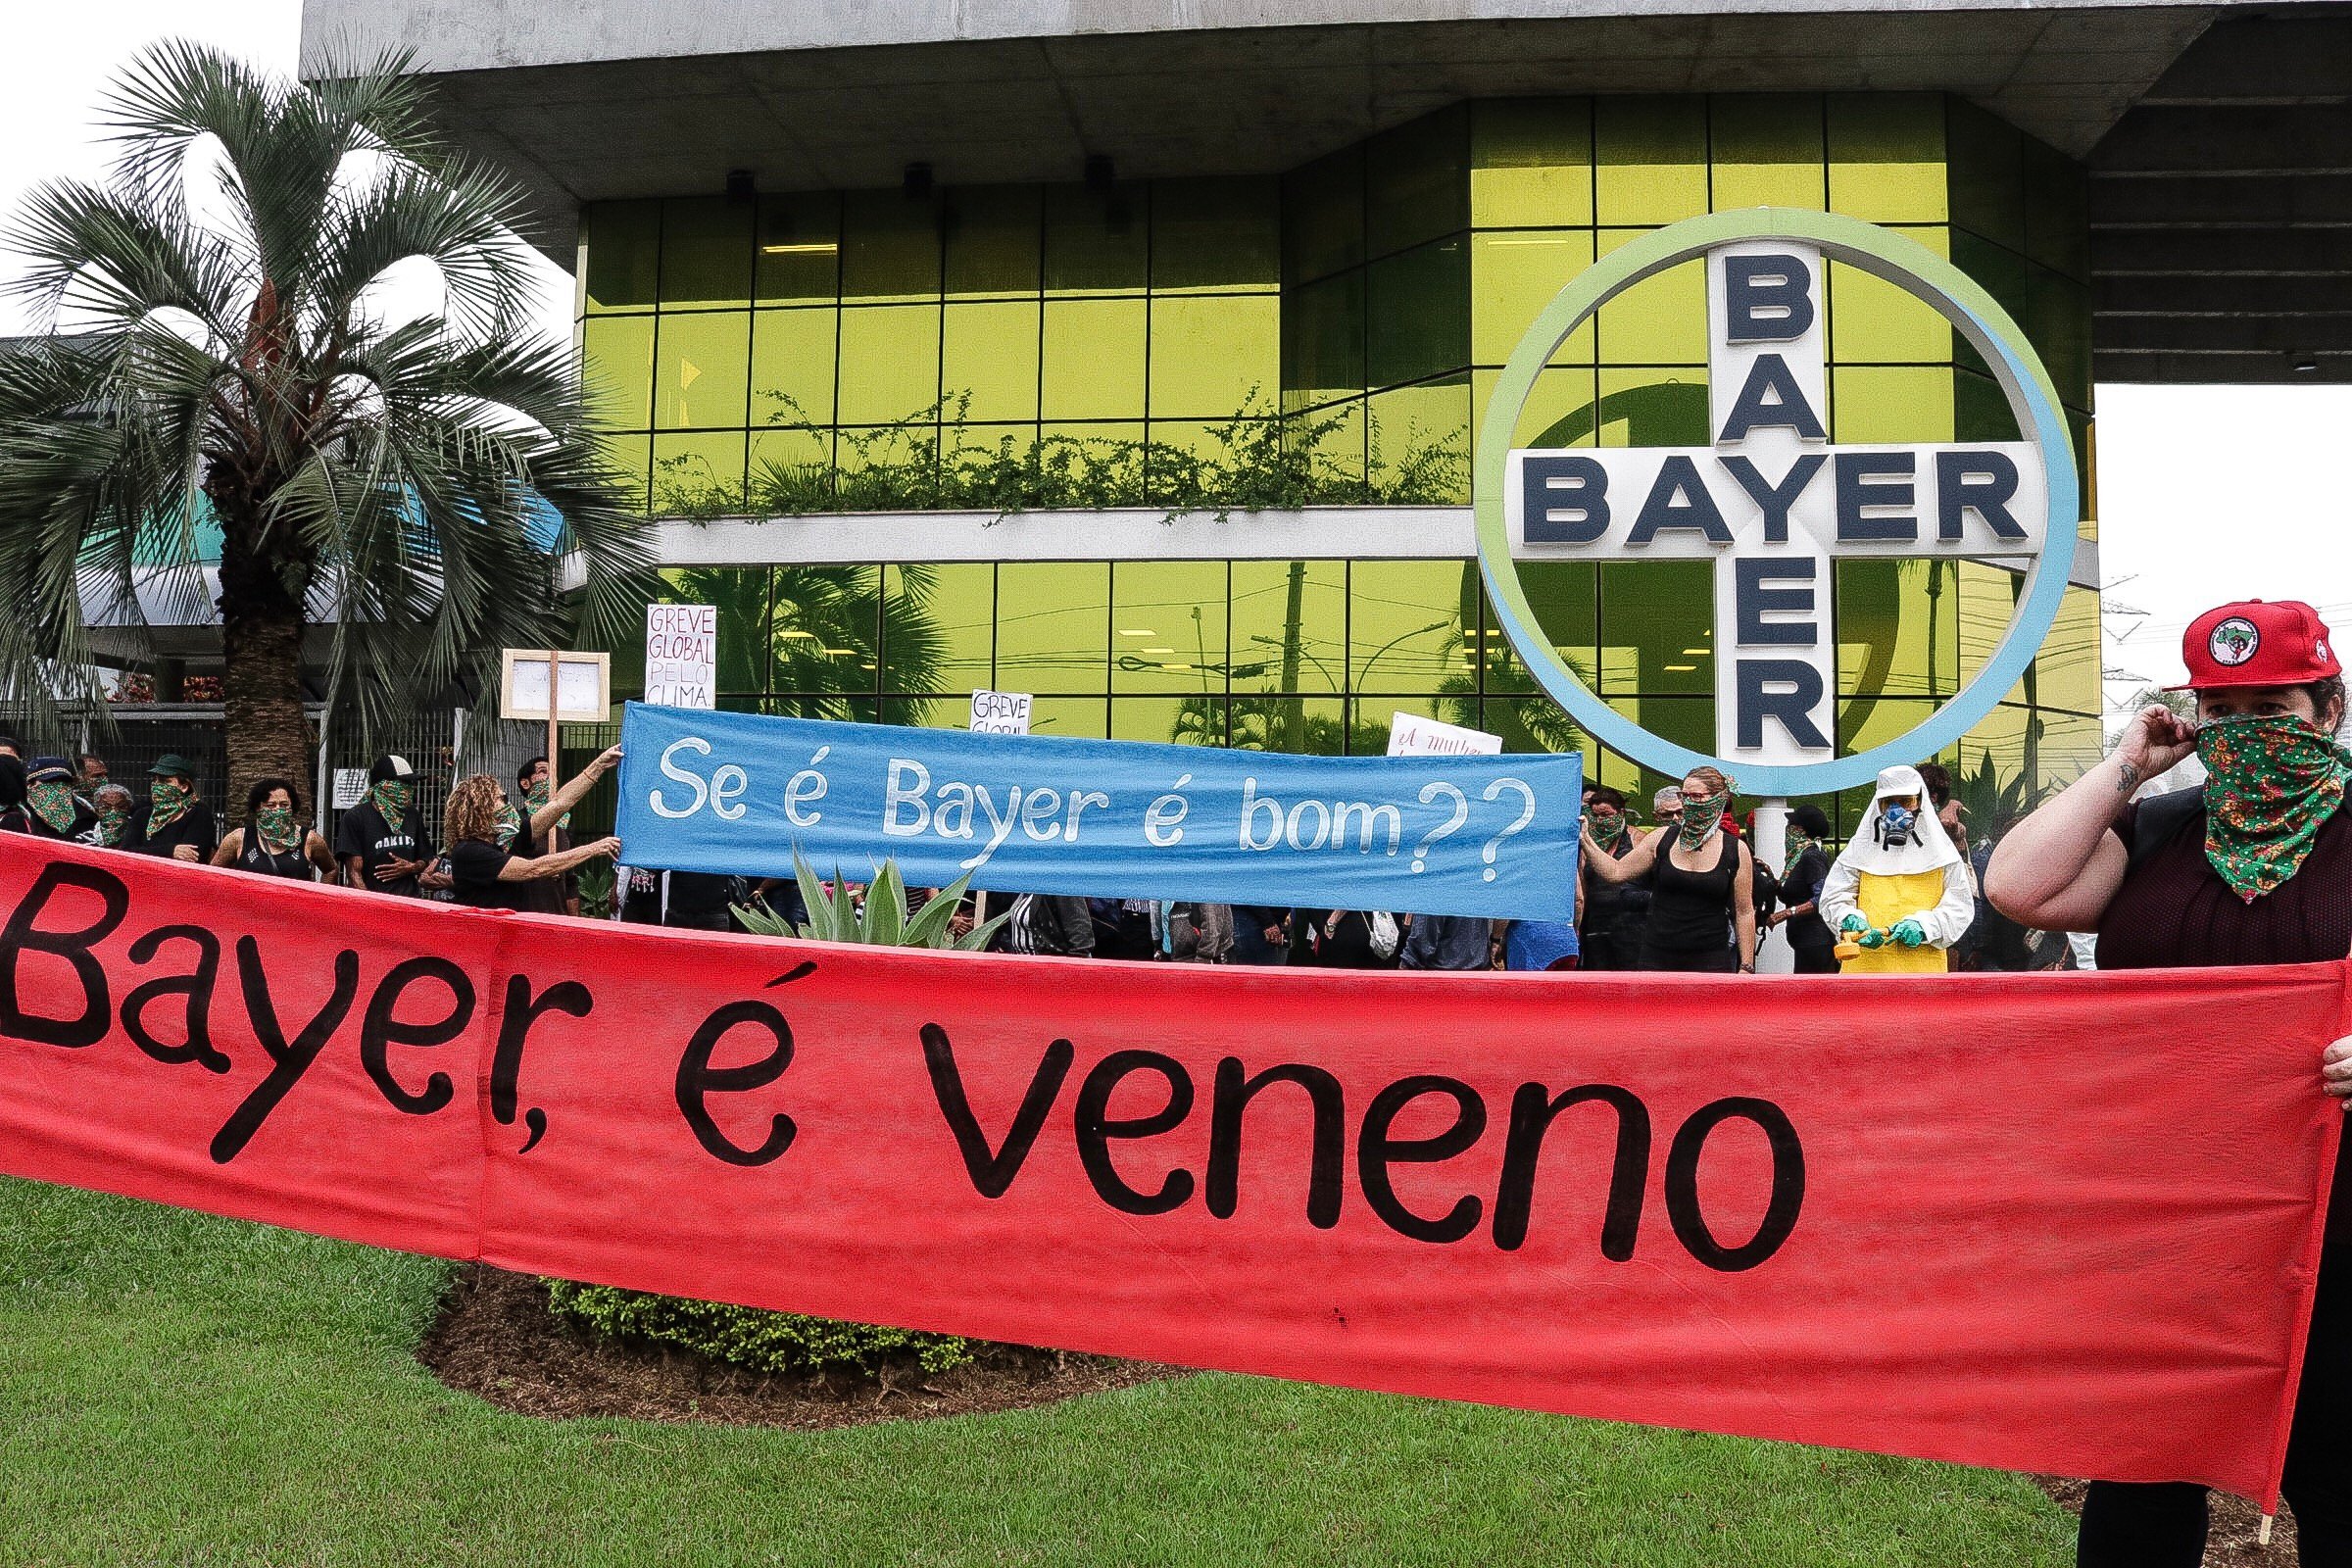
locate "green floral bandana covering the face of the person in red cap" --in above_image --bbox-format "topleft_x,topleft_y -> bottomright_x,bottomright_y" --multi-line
2197,719 -> 2352,903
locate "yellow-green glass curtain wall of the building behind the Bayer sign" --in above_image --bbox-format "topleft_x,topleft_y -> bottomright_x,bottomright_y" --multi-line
578,94 -> 2100,820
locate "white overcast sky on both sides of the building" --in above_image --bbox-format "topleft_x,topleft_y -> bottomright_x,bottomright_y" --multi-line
0,0 -> 2352,728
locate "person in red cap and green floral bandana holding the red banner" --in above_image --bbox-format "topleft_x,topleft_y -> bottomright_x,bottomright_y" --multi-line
1985,600 -> 2352,1568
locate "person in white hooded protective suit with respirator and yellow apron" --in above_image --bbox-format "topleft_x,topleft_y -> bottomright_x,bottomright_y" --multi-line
1821,766 -> 1976,976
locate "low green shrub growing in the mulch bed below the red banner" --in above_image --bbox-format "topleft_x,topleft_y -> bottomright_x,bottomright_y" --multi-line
548,1279 -> 971,1373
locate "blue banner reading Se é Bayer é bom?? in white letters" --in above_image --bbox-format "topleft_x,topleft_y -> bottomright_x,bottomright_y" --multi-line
616,703 -> 1583,919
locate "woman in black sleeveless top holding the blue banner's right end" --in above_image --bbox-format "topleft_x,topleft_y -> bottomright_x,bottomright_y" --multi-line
1583,766 -> 1757,973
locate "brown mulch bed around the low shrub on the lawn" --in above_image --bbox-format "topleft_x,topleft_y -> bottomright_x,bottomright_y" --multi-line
416,1262 -> 1183,1432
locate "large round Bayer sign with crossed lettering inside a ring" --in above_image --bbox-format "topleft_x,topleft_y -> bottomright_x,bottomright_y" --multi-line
1475,209 -> 2082,797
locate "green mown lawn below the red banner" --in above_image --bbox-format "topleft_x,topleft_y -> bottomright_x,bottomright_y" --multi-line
0,1180 -> 2070,1568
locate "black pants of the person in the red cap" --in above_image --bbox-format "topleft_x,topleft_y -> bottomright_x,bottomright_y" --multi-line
2075,1244 -> 2352,1568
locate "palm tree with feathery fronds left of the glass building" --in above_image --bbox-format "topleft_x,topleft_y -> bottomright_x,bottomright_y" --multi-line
0,42 -> 649,797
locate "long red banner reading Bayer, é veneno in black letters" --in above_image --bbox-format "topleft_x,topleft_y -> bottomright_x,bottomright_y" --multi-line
0,837 -> 2347,1502
